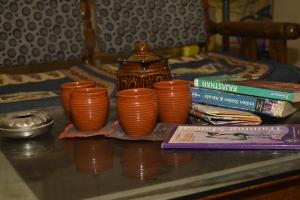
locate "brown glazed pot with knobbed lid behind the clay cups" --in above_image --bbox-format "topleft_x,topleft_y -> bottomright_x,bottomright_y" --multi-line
117,42 -> 172,90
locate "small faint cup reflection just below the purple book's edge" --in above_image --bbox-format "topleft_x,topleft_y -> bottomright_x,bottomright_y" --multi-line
162,151 -> 192,168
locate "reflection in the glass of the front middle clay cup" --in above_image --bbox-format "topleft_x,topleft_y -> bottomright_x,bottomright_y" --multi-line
121,142 -> 161,181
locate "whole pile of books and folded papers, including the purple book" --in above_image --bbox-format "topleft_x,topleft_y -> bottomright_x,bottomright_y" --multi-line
161,76 -> 300,150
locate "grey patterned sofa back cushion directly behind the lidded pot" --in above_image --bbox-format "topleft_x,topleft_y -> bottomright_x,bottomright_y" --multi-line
96,0 -> 207,53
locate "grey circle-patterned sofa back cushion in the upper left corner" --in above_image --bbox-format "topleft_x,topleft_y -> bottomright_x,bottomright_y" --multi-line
0,0 -> 84,66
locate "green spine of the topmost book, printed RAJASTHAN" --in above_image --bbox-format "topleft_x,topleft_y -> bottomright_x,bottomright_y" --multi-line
194,78 -> 293,101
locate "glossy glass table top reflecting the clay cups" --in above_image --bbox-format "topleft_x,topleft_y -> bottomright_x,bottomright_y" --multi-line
0,101 -> 300,200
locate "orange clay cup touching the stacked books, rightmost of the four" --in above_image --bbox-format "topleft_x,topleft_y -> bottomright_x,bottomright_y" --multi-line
153,80 -> 192,124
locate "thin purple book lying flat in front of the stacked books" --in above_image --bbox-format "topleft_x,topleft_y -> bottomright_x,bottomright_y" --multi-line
161,124 -> 300,149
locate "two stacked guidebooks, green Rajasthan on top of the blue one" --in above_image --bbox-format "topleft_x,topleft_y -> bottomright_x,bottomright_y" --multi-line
192,75 -> 300,120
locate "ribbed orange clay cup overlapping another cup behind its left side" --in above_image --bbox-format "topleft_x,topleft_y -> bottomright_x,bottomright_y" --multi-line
70,88 -> 109,131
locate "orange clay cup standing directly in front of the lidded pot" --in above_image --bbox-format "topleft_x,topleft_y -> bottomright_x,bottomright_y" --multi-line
116,88 -> 158,136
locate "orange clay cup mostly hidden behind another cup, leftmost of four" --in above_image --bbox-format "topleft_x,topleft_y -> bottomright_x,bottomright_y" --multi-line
60,80 -> 96,117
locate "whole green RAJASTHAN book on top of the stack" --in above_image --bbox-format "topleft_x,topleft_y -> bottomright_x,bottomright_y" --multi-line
194,78 -> 300,102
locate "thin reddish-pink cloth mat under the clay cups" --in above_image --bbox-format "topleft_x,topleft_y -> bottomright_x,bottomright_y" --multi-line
58,121 -> 176,141
